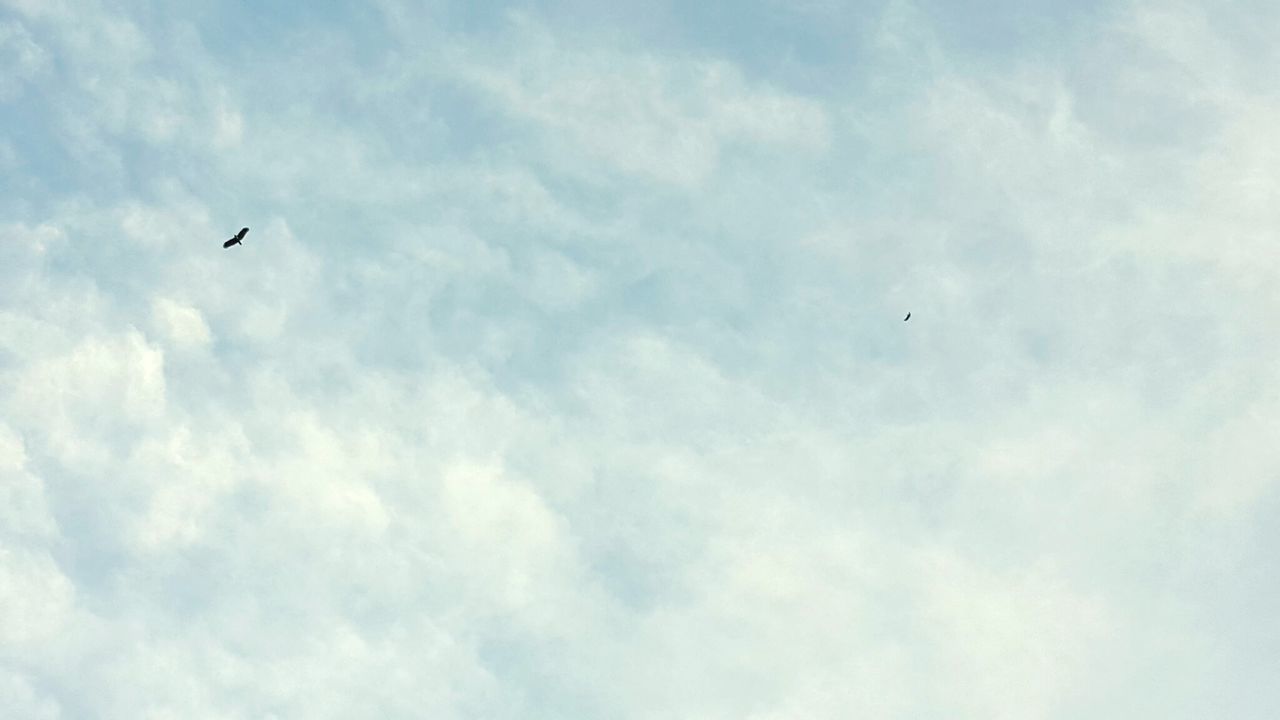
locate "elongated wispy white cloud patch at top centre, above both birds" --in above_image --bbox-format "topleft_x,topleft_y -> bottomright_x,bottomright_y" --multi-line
453,15 -> 828,188
